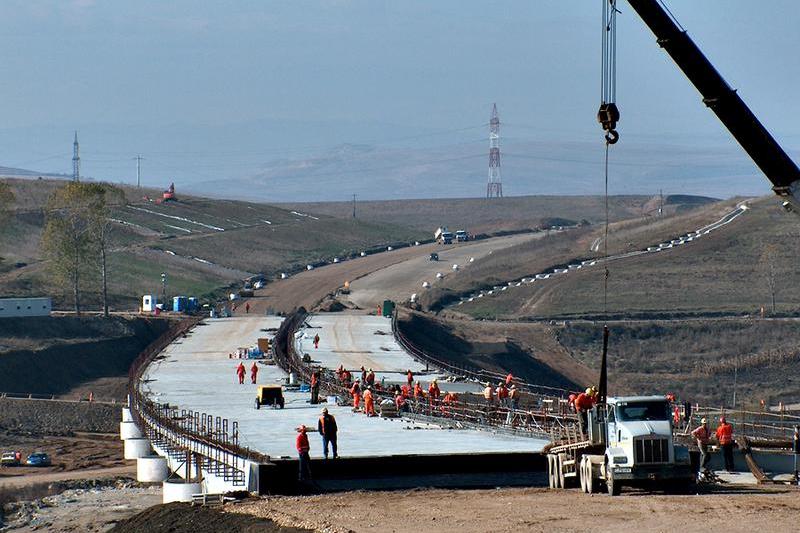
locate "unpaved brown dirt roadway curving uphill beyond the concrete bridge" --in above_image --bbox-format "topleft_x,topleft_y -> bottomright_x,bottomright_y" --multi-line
247,233 -> 544,314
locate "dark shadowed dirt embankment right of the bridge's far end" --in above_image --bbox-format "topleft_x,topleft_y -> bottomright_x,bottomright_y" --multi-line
398,313 -> 596,390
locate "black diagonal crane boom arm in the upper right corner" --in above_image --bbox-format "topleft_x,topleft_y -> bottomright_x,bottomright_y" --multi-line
628,0 -> 800,212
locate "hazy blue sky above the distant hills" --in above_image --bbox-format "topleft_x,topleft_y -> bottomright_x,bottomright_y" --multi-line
0,0 -> 800,198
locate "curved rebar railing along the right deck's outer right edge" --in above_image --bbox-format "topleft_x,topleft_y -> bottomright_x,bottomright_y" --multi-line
392,311 -> 569,398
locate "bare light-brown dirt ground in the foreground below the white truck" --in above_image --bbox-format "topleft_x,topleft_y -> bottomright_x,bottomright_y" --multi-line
229,487 -> 800,533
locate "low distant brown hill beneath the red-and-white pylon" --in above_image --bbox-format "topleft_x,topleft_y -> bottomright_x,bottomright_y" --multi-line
284,192 -> 713,233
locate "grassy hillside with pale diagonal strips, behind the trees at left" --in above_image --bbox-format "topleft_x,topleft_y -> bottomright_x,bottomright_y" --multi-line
0,179 -> 427,309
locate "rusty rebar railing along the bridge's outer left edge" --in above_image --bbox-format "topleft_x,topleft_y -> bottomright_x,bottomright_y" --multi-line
128,317 -> 269,485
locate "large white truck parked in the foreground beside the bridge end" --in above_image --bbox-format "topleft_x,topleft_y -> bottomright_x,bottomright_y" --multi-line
547,396 -> 695,496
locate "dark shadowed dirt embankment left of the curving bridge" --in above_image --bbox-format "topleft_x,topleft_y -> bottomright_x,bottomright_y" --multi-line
0,316 -> 170,400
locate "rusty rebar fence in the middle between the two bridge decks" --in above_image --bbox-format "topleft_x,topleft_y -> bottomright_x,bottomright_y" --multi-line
272,308 -> 577,438
